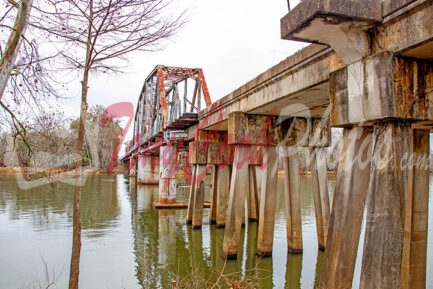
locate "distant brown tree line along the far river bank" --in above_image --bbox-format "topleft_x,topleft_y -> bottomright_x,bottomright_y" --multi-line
0,105 -> 123,170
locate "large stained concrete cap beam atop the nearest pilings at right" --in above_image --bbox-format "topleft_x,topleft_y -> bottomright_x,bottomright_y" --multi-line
330,52 -> 433,127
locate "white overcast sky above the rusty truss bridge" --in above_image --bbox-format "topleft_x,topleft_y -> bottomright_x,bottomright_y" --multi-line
61,0 -> 305,115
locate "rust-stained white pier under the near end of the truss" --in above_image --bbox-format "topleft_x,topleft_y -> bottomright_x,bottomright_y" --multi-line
159,145 -> 178,204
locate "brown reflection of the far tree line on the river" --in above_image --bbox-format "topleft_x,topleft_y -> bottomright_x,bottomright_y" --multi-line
0,176 -> 120,230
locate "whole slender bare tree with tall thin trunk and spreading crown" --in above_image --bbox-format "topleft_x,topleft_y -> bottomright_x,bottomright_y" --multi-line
32,0 -> 185,289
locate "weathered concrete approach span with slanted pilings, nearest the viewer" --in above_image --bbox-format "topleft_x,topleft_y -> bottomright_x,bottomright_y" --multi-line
126,0 -> 433,288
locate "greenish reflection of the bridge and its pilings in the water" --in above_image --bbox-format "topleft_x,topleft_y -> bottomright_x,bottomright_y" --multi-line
130,176 -> 334,288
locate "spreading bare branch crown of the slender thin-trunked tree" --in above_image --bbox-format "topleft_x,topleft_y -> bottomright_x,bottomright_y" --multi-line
32,0 -> 187,71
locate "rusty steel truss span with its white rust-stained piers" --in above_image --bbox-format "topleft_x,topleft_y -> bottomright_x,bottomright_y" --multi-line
123,65 -> 211,197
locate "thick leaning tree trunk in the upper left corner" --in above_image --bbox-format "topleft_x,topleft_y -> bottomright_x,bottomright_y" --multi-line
0,0 -> 33,100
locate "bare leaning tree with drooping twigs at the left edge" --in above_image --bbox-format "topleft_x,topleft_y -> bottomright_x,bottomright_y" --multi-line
0,0 -> 65,160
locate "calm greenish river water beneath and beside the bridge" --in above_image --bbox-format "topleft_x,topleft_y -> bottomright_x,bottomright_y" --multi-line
0,175 -> 433,289
